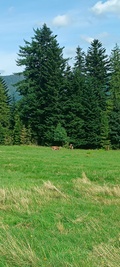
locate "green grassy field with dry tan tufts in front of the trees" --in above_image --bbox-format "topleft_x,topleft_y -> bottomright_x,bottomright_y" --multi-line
0,146 -> 120,267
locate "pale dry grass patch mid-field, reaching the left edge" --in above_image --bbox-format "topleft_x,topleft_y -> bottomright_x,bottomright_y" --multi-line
0,181 -> 67,213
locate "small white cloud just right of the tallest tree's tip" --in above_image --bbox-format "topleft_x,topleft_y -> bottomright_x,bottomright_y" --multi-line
52,15 -> 70,27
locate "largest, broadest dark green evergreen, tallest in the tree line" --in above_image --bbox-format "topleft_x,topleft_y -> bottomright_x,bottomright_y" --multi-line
17,24 -> 67,144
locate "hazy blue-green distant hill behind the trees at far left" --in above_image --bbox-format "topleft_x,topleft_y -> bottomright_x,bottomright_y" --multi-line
2,74 -> 24,100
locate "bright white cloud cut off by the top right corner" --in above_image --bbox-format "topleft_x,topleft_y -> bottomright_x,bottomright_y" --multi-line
92,0 -> 120,15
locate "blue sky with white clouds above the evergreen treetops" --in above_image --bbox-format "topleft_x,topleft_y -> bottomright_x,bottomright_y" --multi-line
0,0 -> 120,75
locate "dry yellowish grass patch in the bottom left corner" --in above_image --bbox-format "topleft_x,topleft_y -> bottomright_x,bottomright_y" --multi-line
0,228 -> 39,267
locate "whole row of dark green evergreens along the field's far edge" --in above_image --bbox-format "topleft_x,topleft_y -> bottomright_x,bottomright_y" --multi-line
0,24 -> 120,149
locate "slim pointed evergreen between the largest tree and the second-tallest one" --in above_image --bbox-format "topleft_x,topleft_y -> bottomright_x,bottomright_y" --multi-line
70,46 -> 85,147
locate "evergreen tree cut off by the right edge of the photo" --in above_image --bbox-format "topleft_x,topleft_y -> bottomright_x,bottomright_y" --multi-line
109,44 -> 120,148
